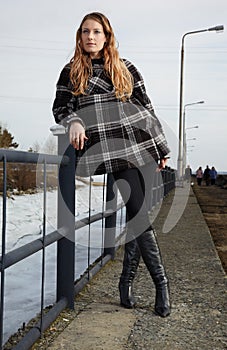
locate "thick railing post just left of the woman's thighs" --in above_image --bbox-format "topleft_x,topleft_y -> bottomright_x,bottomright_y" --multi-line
104,174 -> 117,259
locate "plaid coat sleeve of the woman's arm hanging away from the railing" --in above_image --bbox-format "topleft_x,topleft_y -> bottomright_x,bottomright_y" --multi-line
124,60 -> 170,158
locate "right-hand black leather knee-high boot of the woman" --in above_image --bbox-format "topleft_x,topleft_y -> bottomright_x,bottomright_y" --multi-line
136,229 -> 170,317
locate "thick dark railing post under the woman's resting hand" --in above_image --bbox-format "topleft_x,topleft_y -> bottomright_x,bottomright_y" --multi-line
50,126 -> 75,309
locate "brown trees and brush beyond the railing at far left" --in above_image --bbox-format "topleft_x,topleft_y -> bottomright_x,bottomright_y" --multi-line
0,125 -> 57,194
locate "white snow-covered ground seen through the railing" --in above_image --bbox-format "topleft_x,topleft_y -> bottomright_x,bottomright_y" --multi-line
0,177 -> 125,342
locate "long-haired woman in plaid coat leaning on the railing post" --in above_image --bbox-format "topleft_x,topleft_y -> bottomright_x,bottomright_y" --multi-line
53,12 -> 170,317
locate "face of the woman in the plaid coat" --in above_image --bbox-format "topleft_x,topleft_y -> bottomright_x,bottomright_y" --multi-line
81,19 -> 106,58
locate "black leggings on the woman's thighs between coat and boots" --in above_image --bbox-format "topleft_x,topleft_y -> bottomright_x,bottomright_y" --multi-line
113,162 -> 157,237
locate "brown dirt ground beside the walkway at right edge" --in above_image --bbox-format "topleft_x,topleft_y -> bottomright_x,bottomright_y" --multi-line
193,179 -> 227,274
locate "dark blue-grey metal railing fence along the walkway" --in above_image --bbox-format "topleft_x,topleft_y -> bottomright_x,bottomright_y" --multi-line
0,128 -> 175,350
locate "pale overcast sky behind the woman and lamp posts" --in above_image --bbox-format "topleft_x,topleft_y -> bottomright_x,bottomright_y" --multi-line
0,0 -> 227,171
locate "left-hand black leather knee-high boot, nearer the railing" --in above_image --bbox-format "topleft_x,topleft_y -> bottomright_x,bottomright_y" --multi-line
119,239 -> 140,309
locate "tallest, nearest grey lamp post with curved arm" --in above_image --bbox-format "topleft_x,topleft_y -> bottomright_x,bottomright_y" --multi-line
177,25 -> 224,179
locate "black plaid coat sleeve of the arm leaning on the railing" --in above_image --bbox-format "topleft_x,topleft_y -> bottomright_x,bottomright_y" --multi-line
52,64 -> 85,127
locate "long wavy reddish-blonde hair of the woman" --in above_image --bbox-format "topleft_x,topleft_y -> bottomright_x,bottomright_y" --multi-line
70,12 -> 133,101
